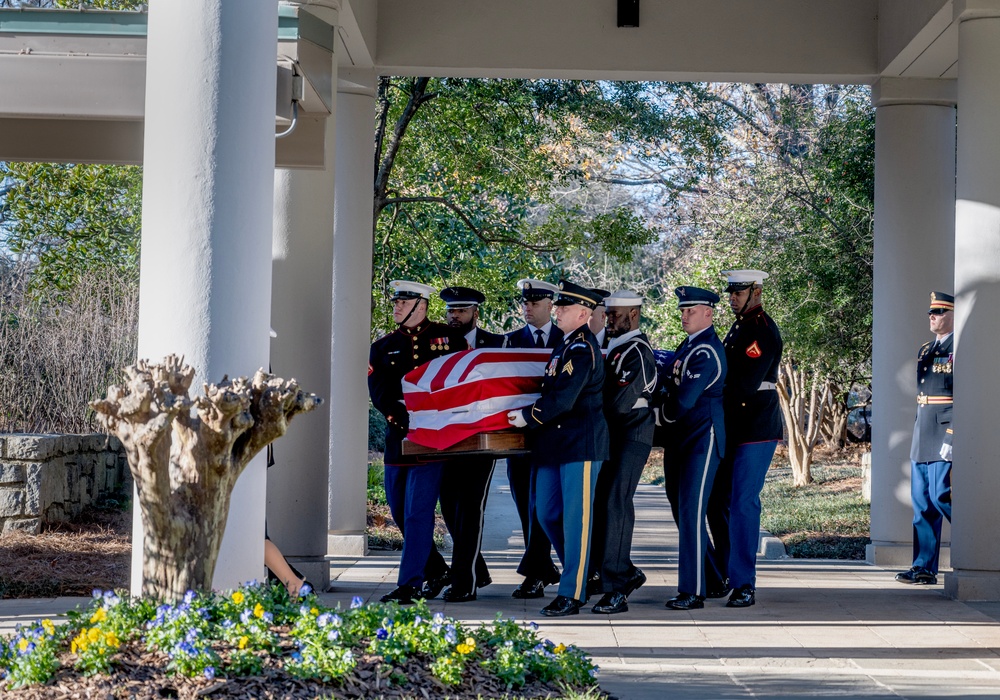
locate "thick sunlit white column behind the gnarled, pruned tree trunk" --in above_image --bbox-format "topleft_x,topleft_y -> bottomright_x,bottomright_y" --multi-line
132,0 -> 278,592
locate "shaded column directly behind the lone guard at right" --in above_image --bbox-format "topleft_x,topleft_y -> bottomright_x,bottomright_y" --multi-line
867,78 -> 956,568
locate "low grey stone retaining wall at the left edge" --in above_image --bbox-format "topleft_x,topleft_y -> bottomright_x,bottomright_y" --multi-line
0,434 -> 132,533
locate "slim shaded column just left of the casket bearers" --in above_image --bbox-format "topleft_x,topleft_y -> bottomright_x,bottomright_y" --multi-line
327,71 -> 375,555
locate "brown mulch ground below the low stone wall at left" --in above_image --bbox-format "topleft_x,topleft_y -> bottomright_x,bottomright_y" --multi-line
0,508 -> 132,598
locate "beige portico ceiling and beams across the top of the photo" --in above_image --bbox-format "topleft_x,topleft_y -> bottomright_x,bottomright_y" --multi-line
0,0 -> 974,167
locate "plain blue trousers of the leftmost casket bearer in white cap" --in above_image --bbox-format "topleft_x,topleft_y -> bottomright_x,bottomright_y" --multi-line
385,462 -> 443,588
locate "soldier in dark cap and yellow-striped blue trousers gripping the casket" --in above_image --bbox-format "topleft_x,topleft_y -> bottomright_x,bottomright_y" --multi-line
508,280 -> 608,617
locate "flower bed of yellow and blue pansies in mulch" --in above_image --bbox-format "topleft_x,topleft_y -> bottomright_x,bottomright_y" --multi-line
0,582 -> 601,698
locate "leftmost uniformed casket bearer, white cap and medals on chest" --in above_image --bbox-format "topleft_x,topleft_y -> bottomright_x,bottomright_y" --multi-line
368,280 -> 467,604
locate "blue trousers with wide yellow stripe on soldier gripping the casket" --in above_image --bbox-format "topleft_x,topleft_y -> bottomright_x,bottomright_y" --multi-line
534,461 -> 601,601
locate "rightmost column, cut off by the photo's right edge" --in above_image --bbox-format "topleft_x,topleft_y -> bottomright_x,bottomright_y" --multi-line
945,0 -> 1000,600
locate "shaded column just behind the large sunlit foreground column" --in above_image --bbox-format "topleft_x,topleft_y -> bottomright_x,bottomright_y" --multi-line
267,2 -> 337,589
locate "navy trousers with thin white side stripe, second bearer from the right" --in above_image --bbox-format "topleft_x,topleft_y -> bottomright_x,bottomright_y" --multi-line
663,428 -> 720,596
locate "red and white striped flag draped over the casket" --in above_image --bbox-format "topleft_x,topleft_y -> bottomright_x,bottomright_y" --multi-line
403,348 -> 552,450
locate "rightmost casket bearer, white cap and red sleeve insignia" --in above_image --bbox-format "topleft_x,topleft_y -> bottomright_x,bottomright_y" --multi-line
706,270 -> 783,608
